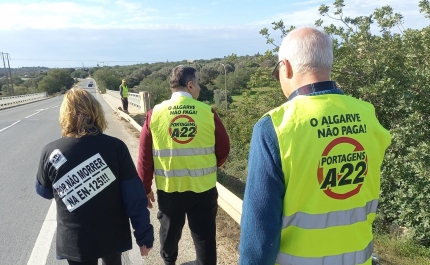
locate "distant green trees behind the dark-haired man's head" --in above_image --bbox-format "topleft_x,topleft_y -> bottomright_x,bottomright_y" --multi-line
90,54 -> 268,107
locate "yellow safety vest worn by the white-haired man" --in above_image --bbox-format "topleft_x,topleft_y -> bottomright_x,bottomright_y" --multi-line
268,94 -> 391,265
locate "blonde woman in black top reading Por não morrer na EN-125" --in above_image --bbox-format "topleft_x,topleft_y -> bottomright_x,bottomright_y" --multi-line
36,88 -> 154,265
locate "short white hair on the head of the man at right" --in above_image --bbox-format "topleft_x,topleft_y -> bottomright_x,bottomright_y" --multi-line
278,27 -> 333,74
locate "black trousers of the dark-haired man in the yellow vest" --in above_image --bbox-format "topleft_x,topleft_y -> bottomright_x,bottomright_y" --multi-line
157,188 -> 218,265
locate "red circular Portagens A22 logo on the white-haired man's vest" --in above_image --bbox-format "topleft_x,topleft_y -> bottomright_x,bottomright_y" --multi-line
317,137 -> 368,200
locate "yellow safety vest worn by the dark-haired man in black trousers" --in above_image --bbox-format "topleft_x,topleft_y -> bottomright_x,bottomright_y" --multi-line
150,96 -> 217,193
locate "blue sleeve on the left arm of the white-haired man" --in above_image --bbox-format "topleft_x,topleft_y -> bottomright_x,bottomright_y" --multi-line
239,117 -> 285,265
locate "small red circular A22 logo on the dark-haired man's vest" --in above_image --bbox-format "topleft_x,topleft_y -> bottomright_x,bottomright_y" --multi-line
169,115 -> 197,144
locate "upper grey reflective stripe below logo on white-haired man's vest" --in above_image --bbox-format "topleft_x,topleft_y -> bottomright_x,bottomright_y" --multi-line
282,200 -> 378,229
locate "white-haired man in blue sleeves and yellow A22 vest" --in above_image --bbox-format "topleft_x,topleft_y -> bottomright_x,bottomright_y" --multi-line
239,27 -> 391,265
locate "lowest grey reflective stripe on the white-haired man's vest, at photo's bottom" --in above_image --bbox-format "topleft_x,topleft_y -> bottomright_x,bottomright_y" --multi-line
276,240 -> 373,265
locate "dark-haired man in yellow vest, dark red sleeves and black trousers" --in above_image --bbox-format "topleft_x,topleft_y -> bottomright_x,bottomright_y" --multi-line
138,65 -> 230,265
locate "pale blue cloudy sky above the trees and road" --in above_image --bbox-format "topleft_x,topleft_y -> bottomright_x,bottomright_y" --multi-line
0,0 -> 430,68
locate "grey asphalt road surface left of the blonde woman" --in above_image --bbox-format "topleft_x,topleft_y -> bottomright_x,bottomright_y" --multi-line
0,93 -> 62,264
